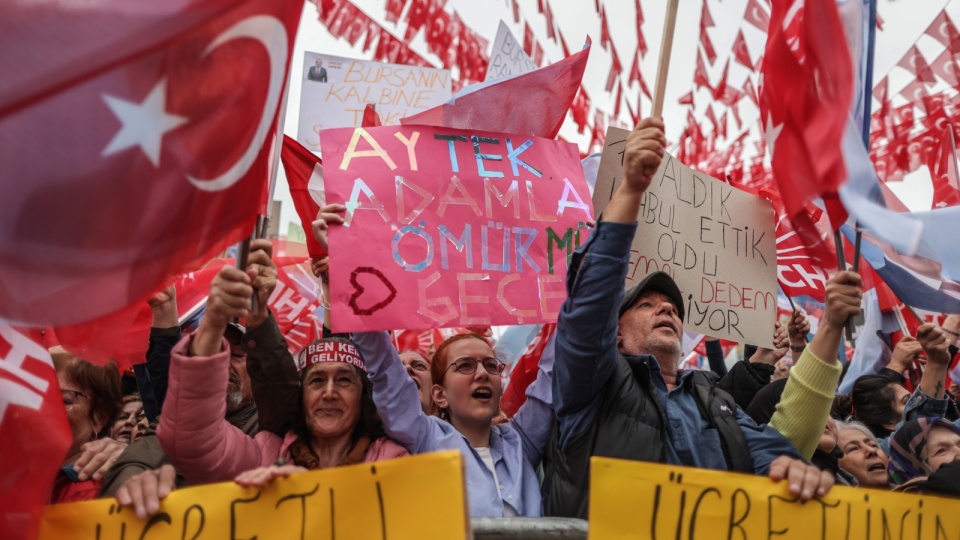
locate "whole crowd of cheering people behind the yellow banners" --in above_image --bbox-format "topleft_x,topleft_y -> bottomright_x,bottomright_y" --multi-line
50,119 -> 960,518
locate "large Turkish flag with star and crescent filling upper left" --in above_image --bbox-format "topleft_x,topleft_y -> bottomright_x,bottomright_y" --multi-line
0,0 -> 302,325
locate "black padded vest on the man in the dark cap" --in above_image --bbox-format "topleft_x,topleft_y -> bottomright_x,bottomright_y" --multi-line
543,355 -> 754,518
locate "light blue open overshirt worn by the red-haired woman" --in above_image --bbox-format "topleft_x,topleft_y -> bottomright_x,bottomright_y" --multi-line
352,332 -> 553,517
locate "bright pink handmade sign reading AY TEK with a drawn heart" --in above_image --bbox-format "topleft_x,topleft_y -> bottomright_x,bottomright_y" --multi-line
320,126 -> 593,332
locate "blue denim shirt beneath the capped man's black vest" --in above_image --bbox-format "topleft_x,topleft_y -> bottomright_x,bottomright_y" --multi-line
553,221 -> 802,474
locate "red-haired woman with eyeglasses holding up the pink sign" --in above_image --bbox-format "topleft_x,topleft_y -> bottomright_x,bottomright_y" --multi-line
313,204 -> 553,517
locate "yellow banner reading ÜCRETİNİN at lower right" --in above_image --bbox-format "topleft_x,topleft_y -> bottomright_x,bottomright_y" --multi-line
590,458 -> 960,540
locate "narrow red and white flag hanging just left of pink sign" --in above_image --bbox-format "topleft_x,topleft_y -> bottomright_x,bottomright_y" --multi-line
280,135 -> 327,257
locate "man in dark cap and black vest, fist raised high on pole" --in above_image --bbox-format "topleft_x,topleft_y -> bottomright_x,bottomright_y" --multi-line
543,118 -> 833,517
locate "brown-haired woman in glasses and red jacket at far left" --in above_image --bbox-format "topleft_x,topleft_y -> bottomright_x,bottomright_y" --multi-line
50,353 -> 120,504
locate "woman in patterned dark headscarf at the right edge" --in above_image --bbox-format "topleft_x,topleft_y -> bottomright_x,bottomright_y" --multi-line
889,418 -> 960,486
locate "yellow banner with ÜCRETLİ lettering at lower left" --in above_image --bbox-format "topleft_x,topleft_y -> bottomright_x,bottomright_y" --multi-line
40,450 -> 470,540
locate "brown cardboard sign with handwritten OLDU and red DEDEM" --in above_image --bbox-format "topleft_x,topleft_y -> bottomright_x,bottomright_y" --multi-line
593,127 -> 777,347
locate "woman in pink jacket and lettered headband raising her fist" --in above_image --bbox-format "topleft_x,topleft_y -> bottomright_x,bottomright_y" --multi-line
157,267 -> 407,490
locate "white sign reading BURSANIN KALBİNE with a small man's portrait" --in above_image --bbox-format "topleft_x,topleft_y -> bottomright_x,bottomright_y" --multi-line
297,52 -> 450,152
